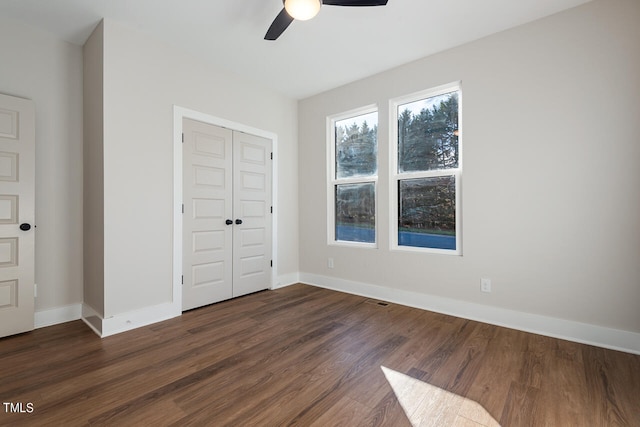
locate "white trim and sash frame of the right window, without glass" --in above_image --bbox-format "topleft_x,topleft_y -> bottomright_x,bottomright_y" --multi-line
389,81 -> 464,256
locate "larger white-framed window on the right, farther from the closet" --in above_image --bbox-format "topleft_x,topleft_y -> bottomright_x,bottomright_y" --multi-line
390,85 -> 462,255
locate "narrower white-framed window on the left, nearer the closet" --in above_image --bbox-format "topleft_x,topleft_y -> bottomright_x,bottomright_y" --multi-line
327,107 -> 378,246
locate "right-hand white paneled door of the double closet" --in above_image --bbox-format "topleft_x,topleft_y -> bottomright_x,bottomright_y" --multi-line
233,132 -> 272,297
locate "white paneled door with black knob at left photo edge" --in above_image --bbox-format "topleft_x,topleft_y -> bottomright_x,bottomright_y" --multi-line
0,95 -> 35,337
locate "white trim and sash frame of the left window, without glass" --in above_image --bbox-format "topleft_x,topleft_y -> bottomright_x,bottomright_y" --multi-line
326,104 -> 380,249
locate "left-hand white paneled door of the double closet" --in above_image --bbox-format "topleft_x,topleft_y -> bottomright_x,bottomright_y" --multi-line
182,119 -> 233,310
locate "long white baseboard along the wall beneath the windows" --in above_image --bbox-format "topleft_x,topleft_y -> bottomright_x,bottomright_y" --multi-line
300,273 -> 640,354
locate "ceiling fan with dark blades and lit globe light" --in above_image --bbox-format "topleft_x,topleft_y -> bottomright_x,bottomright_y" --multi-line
264,0 -> 388,40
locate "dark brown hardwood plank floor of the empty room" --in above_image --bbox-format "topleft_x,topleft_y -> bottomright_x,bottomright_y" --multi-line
0,285 -> 640,426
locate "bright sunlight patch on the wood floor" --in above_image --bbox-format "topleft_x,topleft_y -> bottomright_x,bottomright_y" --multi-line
381,366 -> 500,427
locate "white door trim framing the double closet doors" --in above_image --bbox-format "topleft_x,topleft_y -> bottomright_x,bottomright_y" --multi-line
172,105 -> 278,316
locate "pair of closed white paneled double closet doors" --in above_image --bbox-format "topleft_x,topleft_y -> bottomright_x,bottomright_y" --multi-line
182,119 -> 271,310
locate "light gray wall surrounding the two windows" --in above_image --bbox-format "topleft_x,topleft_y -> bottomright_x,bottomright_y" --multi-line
299,0 -> 640,332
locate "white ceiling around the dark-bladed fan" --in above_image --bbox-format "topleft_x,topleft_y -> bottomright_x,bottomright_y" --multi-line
0,0 -> 590,98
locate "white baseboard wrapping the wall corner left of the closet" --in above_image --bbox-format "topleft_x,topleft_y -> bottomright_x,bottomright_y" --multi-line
82,303 -> 182,338
